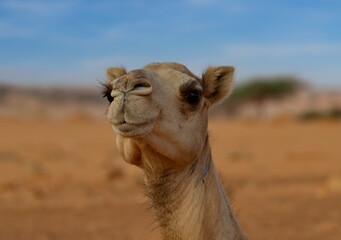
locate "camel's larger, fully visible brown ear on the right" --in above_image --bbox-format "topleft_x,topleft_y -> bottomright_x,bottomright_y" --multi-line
202,66 -> 234,104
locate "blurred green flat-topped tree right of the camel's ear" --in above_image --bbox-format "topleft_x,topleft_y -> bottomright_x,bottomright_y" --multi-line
226,76 -> 303,115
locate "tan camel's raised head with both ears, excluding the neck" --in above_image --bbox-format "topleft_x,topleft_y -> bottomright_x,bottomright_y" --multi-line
104,63 -> 234,170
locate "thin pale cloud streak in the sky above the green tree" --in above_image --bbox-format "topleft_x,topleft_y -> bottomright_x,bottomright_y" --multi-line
225,44 -> 341,58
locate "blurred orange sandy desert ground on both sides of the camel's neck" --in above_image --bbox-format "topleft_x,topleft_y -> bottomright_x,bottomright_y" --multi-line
0,117 -> 341,240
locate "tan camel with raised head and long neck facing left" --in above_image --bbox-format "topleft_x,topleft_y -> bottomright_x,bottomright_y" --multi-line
104,62 -> 247,240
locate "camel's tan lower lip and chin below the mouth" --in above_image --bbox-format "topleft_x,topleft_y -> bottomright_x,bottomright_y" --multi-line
112,122 -> 154,138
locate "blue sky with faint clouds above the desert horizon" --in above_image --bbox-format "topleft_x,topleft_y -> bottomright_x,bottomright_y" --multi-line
0,0 -> 341,87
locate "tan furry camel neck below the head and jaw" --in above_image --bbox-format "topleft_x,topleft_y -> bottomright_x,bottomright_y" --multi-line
146,143 -> 246,240
